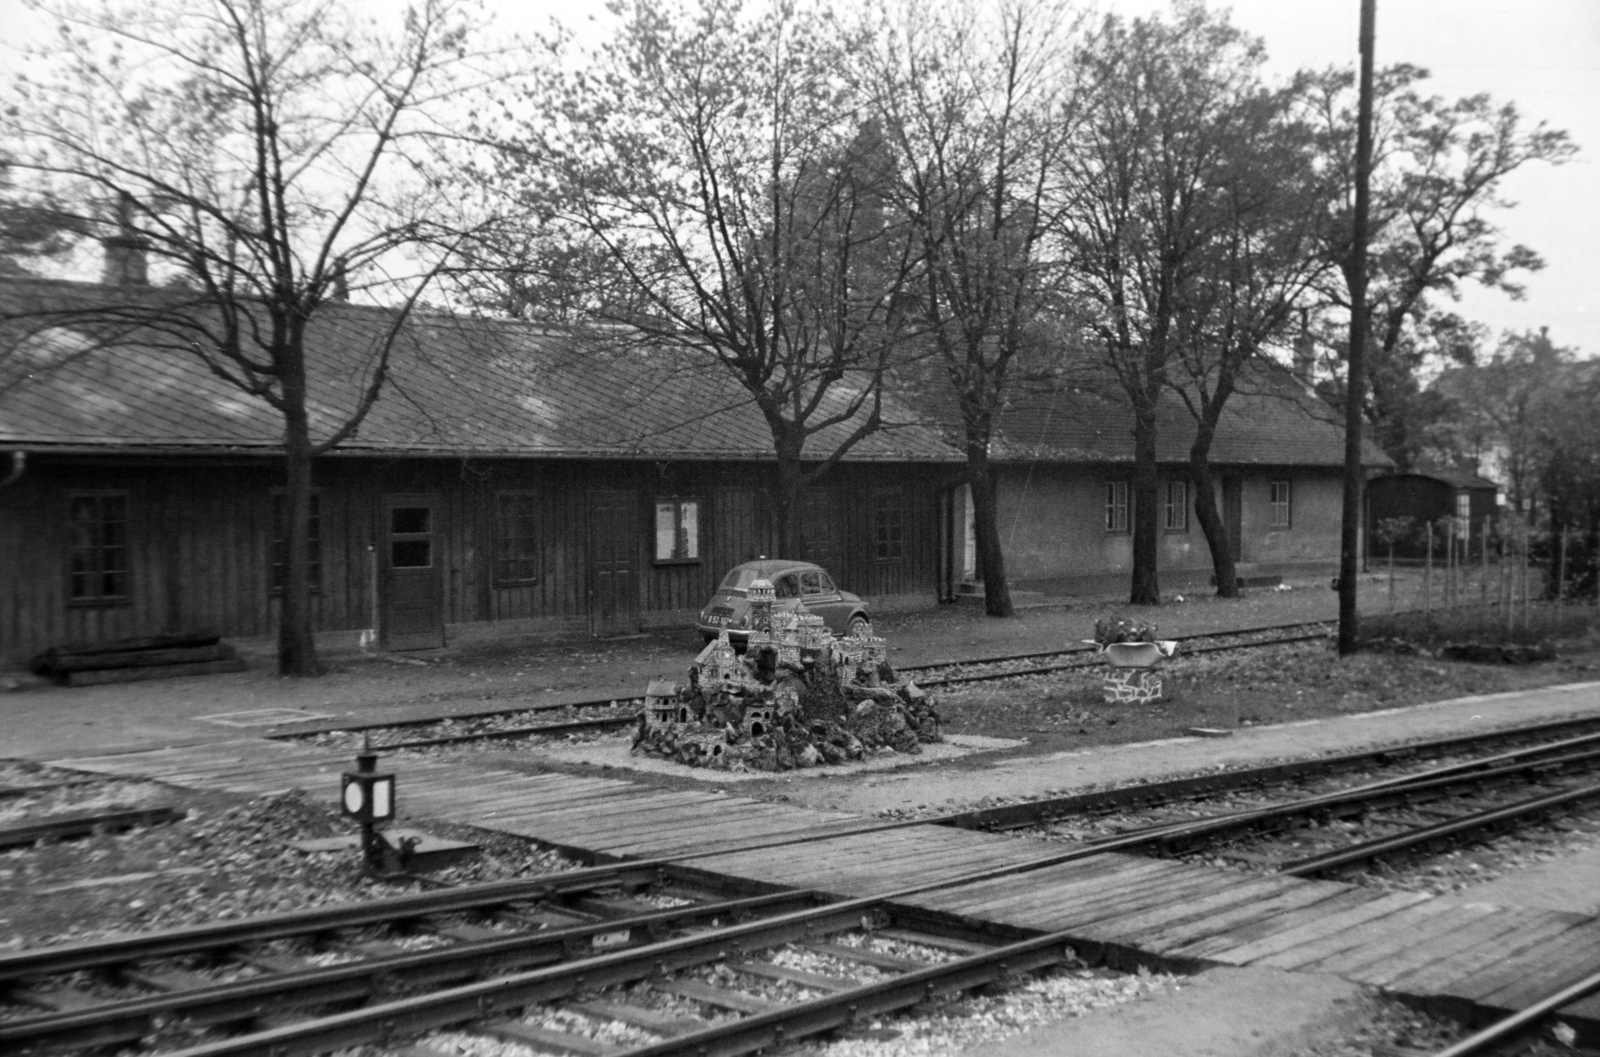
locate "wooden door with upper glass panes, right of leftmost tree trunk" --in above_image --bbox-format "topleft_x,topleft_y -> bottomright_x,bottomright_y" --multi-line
379,496 -> 445,649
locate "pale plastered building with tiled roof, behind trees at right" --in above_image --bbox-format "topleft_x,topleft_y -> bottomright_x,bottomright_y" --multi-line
949,370 -> 1392,595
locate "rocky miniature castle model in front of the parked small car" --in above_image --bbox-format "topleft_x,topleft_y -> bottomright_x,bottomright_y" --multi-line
634,580 -> 942,771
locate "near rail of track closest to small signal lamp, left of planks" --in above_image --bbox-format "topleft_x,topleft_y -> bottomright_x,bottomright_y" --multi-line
0,889 -> 821,1052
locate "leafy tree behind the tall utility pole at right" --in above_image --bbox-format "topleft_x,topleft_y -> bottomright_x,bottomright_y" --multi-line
1301,66 -> 1576,469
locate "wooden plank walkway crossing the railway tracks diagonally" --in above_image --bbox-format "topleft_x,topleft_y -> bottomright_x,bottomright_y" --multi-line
54,739 -> 1600,1028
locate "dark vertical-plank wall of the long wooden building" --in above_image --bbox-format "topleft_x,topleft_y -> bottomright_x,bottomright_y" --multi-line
0,457 -> 949,664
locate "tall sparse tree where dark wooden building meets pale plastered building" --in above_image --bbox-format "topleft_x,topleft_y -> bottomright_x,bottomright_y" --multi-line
875,0 -> 1074,617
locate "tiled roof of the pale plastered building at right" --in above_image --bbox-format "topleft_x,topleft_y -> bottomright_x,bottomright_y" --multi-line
966,365 -> 1390,467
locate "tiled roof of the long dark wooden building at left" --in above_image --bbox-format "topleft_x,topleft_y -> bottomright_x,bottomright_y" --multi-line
0,280 -> 960,462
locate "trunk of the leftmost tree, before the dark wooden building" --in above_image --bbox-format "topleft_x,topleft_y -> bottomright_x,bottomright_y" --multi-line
278,357 -> 322,676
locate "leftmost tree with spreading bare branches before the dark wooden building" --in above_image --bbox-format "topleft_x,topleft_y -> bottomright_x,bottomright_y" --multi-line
0,0 -> 499,675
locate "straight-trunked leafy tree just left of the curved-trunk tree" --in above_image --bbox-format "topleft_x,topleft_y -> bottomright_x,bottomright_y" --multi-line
1061,3 -> 1286,604
